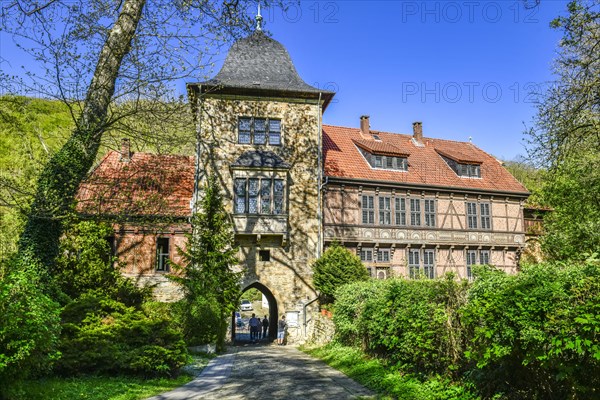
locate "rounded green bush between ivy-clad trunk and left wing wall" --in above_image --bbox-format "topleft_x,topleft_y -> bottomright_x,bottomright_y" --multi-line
54,221 -> 150,306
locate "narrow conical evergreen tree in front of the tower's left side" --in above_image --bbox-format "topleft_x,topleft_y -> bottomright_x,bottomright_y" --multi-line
172,175 -> 241,351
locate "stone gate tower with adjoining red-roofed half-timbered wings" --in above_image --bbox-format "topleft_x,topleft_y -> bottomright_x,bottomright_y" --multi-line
79,29 -> 528,338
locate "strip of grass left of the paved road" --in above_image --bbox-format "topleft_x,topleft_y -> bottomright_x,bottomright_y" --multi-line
1,375 -> 191,400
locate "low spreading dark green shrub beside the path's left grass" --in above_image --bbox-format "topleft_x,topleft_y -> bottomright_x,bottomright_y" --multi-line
56,294 -> 188,377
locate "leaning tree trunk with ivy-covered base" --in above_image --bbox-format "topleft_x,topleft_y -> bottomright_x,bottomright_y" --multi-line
19,0 -> 146,273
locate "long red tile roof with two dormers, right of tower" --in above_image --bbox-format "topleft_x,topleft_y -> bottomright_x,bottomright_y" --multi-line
323,125 -> 527,194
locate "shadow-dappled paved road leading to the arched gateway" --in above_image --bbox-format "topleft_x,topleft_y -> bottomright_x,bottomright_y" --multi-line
148,345 -> 374,400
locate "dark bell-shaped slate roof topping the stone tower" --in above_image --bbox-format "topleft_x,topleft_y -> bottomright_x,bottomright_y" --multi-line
189,31 -> 335,106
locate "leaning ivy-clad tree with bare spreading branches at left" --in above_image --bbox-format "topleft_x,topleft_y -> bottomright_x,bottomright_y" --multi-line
0,0 -> 284,284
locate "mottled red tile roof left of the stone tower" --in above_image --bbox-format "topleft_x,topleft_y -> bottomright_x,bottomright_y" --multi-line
77,151 -> 194,217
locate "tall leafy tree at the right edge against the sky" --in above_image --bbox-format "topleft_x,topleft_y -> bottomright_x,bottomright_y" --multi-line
528,0 -> 600,259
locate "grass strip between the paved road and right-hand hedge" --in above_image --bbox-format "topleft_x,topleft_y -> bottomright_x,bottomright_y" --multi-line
301,343 -> 478,400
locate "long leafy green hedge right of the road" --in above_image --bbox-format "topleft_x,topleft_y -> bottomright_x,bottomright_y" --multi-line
334,259 -> 600,399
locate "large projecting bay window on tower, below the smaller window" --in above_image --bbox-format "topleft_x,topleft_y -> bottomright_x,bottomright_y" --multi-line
233,178 -> 285,214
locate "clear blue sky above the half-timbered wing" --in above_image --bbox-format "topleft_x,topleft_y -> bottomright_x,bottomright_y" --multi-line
0,0 -> 567,160
